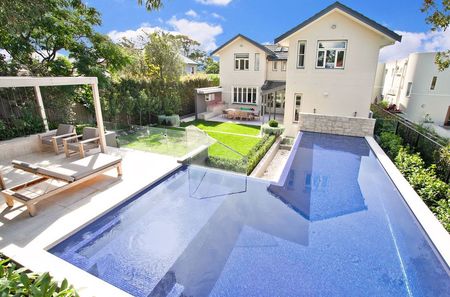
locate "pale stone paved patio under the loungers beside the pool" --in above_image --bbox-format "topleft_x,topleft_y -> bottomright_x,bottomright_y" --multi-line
0,148 -> 180,296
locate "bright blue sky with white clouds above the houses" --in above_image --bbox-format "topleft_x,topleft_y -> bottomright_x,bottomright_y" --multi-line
85,0 -> 450,61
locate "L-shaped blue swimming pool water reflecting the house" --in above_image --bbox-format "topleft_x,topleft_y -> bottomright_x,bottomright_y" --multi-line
50,133 -> 450,296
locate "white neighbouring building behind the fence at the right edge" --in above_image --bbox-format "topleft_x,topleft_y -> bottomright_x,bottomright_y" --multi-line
378,53 -> 450,132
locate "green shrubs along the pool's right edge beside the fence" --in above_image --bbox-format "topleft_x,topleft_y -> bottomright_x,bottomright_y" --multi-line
380,132 -> 450,232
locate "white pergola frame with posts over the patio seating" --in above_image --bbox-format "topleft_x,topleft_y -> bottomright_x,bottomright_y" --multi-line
0,76 -> 106,153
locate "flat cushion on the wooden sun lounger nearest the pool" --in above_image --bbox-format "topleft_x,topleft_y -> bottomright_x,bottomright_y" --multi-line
37,153 -> 122,183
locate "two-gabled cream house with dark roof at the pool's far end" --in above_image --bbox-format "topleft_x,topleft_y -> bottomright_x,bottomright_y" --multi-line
204,2 -> 401,135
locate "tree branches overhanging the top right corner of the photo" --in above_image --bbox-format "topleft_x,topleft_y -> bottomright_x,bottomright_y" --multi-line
421,0 -> 450,71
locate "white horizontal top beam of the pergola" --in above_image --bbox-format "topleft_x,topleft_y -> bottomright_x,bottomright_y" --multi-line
0,76 -> 98,88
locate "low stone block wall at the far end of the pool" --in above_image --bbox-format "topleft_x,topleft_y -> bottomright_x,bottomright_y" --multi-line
298,113 -> 375,137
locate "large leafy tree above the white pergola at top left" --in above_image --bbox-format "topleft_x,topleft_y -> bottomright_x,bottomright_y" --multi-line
0,0 -> 128,80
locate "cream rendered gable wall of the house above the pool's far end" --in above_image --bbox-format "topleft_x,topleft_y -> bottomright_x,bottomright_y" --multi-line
281,11 -> 391,135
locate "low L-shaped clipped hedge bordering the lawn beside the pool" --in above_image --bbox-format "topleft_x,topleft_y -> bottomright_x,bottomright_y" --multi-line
207,135 -> 276,175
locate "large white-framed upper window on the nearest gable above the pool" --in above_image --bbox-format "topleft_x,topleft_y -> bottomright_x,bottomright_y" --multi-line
316,41 -> 347,69
